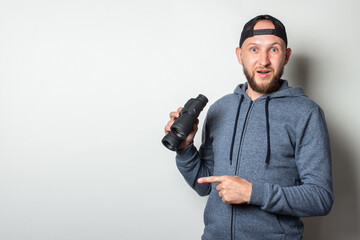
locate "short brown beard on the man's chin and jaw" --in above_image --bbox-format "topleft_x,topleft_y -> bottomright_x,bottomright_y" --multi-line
243,66 -> 284,94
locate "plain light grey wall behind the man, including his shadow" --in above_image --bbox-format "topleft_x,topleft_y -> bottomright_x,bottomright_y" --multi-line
0,0 -> 360,240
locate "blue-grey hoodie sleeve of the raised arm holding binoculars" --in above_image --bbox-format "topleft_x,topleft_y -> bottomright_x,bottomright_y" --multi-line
176,114 -> 214,196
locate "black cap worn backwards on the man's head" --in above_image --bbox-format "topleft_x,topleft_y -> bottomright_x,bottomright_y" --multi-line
239,15 -> 287,47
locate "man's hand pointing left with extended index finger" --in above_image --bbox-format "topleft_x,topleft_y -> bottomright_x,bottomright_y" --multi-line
198,176 -> 252,204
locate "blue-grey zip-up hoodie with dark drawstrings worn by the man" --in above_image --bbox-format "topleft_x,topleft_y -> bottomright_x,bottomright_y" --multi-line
176,80 -> 334,240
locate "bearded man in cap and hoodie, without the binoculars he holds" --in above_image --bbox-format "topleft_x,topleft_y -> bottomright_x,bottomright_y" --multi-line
165,15 -> 334,240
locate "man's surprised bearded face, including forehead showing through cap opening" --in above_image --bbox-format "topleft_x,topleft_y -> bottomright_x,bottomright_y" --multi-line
236,20 -> 291,94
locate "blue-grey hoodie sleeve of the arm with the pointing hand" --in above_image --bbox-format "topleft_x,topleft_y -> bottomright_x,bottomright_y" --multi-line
249,106 -> 334,217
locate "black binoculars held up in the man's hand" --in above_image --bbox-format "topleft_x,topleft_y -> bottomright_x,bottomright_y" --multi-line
162,94 -> 208,151
